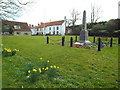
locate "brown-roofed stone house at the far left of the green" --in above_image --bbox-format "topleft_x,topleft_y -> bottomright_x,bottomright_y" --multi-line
1,20 -> 31,35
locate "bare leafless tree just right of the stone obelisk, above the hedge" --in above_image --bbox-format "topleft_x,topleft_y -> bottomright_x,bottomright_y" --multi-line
91,5 -> 102,23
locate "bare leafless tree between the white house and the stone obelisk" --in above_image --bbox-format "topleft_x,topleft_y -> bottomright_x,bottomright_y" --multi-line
68,9 -> 80,30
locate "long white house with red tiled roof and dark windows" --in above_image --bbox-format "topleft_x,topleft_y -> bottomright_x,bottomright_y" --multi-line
37,20 -> 66,35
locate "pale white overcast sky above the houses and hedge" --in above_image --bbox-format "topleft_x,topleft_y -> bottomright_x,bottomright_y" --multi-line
16,0 -> 120,25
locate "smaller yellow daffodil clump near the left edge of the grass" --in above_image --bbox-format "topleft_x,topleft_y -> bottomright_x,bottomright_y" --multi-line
2,48 -> 19,56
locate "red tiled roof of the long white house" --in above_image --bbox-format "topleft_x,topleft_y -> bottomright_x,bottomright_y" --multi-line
37,20 -> 64,28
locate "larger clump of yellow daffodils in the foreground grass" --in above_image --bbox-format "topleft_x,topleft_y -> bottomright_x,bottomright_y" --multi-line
26,60 -> 60,82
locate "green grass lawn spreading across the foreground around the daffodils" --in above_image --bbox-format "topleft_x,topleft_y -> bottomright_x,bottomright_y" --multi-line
2,36 -> 118,88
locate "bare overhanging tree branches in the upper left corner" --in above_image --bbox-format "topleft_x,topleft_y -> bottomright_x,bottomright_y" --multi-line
0,0 -> 31,19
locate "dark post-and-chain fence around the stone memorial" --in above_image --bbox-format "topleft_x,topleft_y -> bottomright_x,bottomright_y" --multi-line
46,36 -> 120,51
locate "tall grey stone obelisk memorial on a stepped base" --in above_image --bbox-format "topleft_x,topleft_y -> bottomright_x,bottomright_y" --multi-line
79,10 -> 92,45
